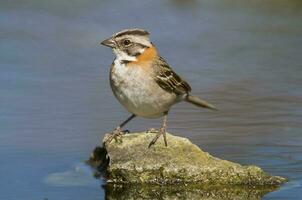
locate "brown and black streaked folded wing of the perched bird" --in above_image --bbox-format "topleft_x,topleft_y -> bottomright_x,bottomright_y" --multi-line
155,57 -> 191,95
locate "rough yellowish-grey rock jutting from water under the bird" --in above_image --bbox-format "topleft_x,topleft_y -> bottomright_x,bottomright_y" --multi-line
88,132 -> 286,187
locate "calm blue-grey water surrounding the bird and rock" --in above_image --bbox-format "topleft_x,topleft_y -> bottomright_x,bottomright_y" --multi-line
0,0 -> 302,200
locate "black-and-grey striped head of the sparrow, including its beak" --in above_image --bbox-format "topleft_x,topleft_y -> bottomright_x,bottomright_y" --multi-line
101,29 -> 153,62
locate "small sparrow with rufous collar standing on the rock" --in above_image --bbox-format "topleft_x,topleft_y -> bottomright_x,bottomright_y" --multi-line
101,28 -> 217,148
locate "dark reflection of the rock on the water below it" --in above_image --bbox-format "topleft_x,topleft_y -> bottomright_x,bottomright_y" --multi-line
103,183 -> 276,200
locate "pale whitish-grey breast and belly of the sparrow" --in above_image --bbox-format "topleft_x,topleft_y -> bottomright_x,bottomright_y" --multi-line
110,61 -> 177,118
